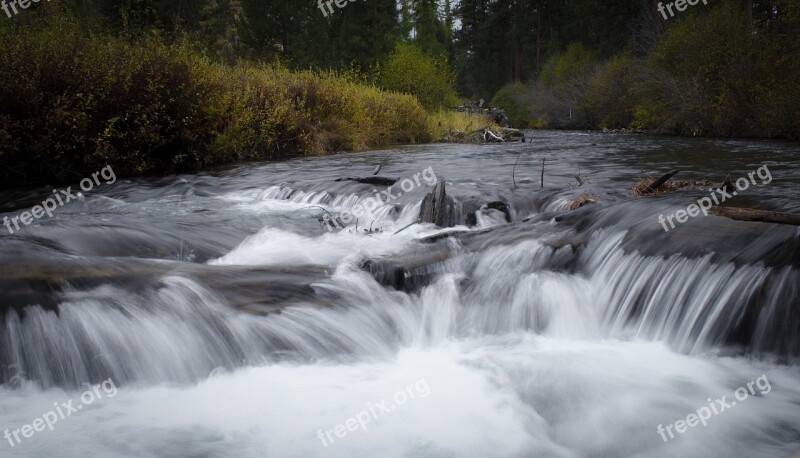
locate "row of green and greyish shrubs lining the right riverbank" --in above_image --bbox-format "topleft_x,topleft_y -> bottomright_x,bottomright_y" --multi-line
524,5 -> 800,138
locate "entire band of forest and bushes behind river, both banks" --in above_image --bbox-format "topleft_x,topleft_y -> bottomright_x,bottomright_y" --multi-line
0,0 -> 800,182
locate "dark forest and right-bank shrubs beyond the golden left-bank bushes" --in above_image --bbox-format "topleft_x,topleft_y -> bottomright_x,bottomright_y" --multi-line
47,0 -> 800,138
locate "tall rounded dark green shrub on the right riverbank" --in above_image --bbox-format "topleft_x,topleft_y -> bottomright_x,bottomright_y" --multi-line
635,5 -> 759,136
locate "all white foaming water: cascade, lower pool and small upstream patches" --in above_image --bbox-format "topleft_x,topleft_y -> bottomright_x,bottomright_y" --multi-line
0,178 -> 800,457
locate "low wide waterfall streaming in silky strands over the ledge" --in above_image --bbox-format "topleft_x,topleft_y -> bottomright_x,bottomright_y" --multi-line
0,224 -> 800,386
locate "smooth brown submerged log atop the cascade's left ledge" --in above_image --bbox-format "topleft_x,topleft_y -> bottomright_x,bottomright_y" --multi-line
0,254 -> 334,316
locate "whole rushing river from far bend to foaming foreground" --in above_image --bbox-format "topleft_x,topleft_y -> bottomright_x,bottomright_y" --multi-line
0,132 -> 800,457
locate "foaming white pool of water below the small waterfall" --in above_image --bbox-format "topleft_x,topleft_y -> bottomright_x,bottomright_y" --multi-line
0,332 -> 800,457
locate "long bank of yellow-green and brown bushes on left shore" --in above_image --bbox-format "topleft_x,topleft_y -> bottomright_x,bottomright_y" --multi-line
0,18 -> 431,185
